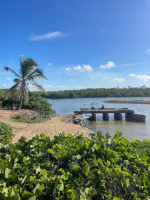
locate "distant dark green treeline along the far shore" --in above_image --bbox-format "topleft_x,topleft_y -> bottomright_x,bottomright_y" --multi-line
38,87 -> 150,99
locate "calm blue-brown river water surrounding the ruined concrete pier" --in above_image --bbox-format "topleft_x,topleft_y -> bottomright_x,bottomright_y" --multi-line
48,97 -> 150,140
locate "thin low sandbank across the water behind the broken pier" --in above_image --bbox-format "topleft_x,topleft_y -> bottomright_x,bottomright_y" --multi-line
104,100 -> 150,104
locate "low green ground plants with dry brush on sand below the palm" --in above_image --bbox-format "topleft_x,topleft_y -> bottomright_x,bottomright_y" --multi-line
13,115 -> 46,124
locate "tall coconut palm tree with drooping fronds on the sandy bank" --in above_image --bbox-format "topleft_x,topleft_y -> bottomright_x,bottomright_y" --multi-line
4,56 -> 47,109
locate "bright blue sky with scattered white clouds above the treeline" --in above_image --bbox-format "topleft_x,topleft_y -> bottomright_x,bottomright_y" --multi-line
0,0 -> 150,90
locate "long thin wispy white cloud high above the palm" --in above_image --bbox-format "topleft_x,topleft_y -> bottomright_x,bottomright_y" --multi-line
30,31 -> 65,41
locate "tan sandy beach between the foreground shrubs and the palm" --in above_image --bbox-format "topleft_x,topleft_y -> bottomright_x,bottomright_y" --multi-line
0,110 -> 91,142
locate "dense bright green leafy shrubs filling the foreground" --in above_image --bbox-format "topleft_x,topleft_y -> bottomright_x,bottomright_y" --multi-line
0,132 -> 150,200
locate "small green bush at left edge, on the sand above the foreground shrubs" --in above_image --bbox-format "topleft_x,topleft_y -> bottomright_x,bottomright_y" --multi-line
0,122 -> 13,145
